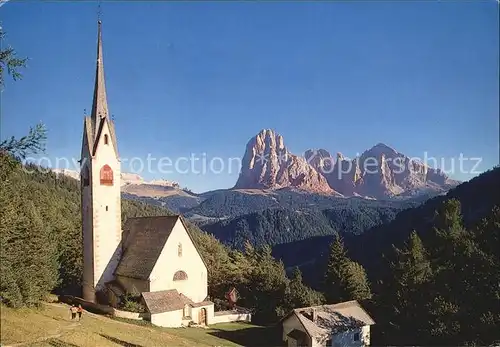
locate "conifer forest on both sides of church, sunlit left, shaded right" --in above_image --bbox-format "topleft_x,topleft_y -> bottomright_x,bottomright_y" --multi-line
0,23 -> 500,346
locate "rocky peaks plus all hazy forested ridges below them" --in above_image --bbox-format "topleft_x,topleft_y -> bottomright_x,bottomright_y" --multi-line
49,130 -> 459,256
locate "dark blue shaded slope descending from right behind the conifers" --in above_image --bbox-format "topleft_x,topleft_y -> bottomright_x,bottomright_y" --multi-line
273,167 -> 500,287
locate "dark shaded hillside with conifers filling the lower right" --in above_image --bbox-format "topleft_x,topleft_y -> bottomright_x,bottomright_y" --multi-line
274,167 -> 500,345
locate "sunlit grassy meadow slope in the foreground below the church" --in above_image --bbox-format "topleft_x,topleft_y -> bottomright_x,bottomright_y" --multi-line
0,303 -> 279,347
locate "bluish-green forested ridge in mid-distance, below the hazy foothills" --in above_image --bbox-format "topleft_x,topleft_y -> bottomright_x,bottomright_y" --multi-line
201,199 -> 406,253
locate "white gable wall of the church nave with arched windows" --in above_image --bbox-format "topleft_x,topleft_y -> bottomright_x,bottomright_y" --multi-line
150,220 -> 208,302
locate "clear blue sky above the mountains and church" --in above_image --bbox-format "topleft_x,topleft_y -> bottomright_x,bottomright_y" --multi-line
0,0 -> 499,191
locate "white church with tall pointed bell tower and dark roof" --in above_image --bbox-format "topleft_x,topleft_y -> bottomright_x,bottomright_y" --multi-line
80,21 -> 251,327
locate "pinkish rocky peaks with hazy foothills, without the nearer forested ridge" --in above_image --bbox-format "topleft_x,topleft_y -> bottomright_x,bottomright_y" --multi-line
54,130 -> 460,220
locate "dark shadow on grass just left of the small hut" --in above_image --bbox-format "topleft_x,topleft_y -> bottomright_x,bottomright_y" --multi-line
209,327 -> 283,347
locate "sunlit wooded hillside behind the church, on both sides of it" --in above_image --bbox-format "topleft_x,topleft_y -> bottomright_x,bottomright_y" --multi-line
0,153 -> 322,322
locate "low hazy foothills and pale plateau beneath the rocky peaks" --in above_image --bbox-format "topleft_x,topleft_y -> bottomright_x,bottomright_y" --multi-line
54,170 -> 436,226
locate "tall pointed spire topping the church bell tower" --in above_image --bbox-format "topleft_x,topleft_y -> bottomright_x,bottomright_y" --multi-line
91,20 -> 108,136
